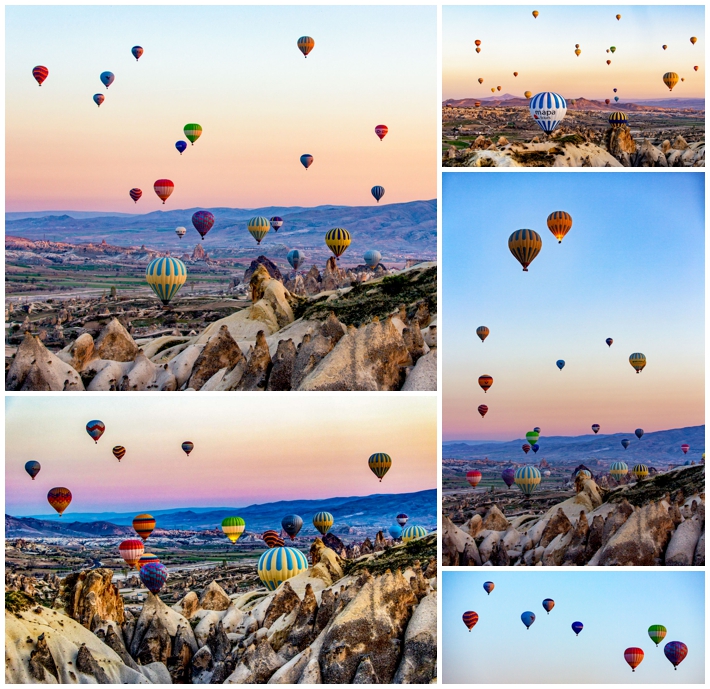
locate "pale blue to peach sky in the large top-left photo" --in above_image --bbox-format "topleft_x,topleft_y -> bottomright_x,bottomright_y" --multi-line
5,5 -> 439,213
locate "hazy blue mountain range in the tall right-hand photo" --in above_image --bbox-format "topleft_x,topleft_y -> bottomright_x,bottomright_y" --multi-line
443,426 -> 705,465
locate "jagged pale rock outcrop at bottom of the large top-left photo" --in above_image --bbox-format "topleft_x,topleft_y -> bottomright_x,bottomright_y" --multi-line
6,264 -> 436,391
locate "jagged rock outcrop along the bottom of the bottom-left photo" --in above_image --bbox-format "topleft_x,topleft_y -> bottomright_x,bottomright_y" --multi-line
5,534 -> 437,684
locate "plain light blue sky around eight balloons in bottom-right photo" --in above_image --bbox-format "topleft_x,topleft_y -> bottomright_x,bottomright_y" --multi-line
442,568 -> 705,685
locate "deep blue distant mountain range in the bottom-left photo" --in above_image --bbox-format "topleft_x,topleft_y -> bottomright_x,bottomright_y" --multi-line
5,489 -> 437,538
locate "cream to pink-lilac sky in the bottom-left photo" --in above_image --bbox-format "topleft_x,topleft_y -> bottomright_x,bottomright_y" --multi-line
5,394 -> 437,516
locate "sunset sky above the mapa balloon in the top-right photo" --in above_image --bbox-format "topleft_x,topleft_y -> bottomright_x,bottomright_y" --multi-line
443,5 -> 705,103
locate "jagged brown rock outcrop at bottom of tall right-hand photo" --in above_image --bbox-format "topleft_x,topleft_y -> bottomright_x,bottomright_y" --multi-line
442,465 -> 705,566
